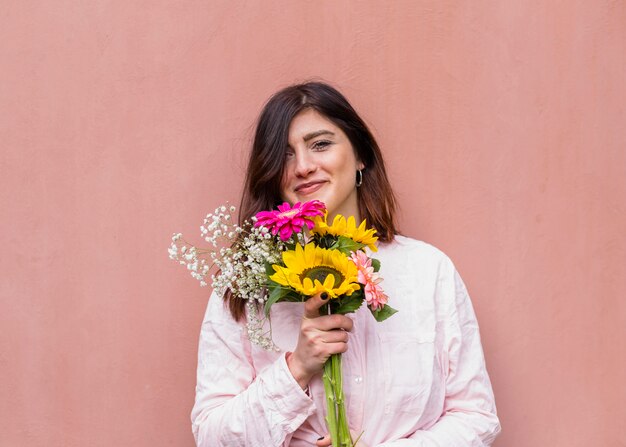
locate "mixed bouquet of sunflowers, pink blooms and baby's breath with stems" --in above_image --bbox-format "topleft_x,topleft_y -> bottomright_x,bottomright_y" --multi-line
169,200 -> 396,447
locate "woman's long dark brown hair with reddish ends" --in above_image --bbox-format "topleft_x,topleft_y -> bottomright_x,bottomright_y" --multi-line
224,82 -> 397,320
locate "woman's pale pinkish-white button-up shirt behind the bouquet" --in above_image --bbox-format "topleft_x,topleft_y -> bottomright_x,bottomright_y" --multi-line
191,236 -> 500,447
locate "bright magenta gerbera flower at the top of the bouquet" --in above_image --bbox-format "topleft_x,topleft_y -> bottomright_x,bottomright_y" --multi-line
254,200 -> 326,241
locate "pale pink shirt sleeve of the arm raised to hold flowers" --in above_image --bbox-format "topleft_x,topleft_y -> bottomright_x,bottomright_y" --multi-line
191,293 -> 315,447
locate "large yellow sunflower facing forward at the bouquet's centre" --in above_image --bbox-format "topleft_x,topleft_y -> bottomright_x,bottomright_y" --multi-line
270,243 -> 361,298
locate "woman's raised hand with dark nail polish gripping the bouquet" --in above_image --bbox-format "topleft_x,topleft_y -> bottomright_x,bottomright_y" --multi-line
287,294 -> 352,389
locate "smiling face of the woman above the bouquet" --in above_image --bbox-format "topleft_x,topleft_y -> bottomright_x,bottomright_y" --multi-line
281,109 -> 364,222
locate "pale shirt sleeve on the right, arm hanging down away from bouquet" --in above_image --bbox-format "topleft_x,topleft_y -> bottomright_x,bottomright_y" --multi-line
378,262 -> 500,447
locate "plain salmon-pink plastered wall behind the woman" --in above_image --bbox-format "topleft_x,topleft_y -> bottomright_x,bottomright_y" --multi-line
0,0 -> 626,447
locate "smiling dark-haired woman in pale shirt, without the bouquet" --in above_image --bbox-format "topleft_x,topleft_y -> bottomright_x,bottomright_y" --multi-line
192,82 -> 500,447
